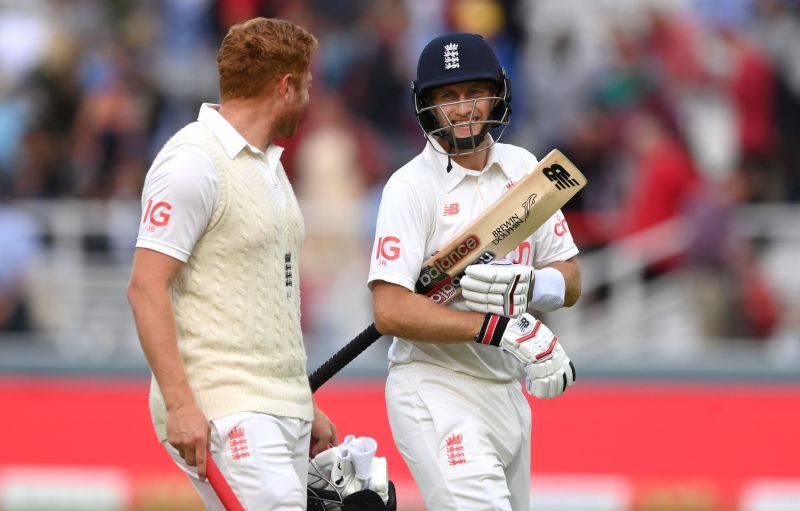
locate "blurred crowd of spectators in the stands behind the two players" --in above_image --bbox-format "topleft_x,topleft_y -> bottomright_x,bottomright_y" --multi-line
0,0 -> 800,344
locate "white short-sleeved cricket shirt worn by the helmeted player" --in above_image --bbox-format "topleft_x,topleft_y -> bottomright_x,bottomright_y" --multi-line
368,140 -> 578,380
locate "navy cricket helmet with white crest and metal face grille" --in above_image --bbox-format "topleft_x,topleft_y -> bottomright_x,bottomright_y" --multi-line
411,33 -> 511,155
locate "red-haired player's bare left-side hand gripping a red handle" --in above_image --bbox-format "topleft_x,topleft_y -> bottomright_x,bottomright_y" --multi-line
167,402 -> 211,481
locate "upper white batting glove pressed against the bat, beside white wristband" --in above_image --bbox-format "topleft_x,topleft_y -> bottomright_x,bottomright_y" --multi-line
460,261 -> 533,317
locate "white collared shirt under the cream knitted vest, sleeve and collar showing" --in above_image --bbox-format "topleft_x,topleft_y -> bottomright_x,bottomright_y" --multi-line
136,103 -> 286,263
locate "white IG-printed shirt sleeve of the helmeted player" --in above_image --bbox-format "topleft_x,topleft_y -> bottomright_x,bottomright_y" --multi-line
367,179 -> 431,291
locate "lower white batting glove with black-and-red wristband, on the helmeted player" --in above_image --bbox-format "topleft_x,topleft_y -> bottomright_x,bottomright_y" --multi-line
475,313 -> 577,399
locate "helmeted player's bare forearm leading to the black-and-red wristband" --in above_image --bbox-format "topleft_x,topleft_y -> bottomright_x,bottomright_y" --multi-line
373,282 -> 485,342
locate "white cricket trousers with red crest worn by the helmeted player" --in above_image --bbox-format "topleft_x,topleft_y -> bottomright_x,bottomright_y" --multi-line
386,362 -> 531,511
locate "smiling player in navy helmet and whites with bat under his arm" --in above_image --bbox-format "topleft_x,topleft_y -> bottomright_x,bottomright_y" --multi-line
368,33 -> 581,511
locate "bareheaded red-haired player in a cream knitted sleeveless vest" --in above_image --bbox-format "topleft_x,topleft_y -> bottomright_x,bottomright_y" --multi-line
128,18 -> 337,510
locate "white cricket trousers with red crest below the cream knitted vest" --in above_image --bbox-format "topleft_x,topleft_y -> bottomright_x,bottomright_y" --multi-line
162,412 -> 311,511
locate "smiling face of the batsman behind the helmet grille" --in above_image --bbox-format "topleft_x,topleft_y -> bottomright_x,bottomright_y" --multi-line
428,82 -> 497,143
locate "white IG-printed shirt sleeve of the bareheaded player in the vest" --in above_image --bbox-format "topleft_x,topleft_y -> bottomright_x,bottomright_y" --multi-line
136,145 -> 218,263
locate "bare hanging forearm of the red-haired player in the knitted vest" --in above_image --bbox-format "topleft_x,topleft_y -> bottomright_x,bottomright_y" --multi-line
128,286 -> 194,410
